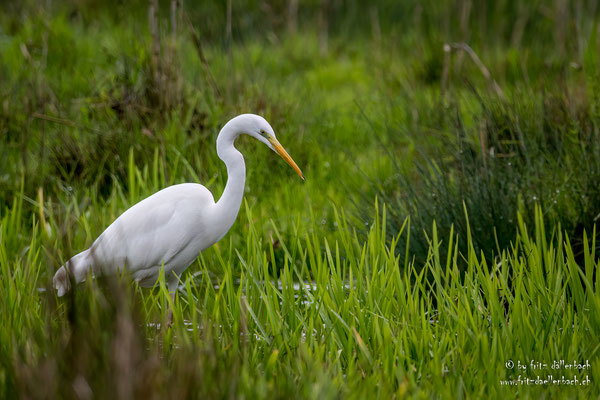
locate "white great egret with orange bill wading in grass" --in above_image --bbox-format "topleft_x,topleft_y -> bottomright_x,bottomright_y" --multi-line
53,114 -> 304,296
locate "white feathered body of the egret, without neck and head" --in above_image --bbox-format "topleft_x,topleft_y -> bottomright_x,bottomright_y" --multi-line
59,183 -> 220,294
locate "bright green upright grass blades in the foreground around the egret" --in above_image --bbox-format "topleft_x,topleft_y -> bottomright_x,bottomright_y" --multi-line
0,181 -> 600,398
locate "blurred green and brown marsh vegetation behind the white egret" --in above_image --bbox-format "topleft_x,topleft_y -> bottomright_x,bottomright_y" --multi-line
0,0 -> 600,268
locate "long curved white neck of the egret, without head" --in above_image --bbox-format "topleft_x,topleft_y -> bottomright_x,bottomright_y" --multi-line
215,124 -> 246,239
